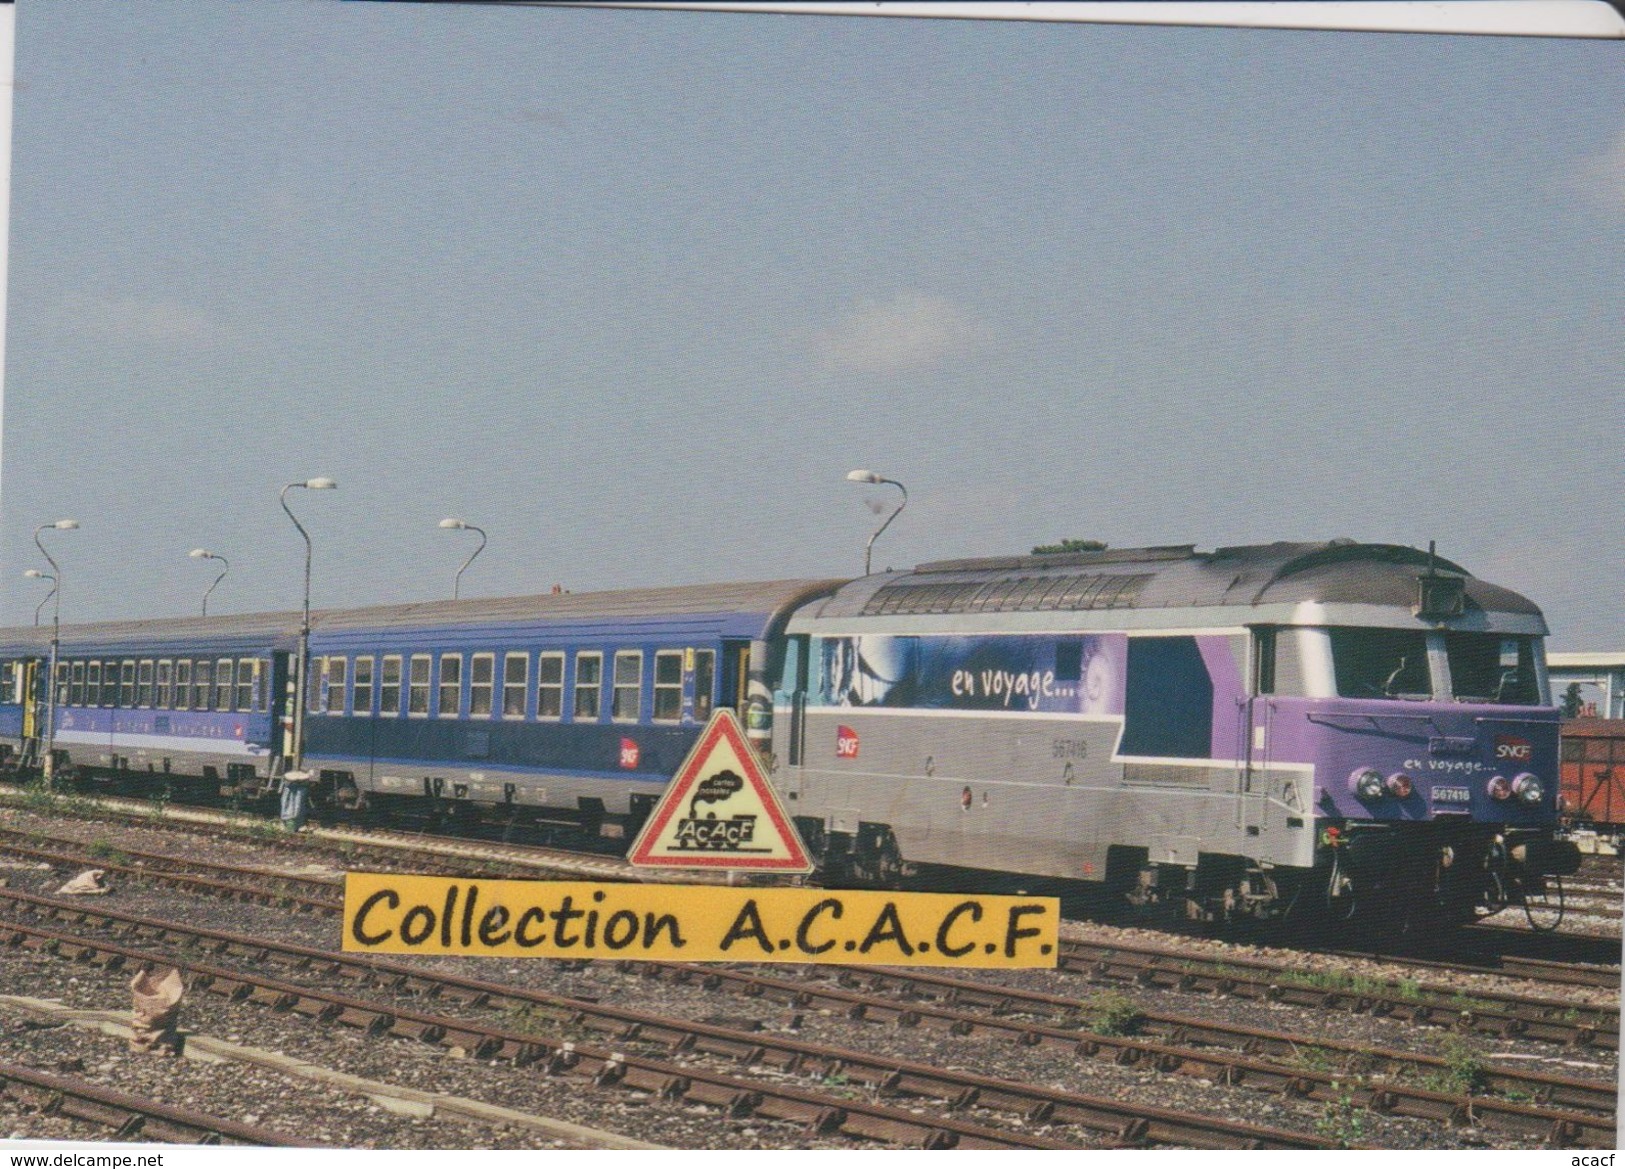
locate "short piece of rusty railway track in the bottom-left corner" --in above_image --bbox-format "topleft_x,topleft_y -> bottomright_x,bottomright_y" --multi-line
0,1063 -> 325,1148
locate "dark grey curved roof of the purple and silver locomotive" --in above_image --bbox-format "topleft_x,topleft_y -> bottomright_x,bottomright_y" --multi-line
814,540 -> 1541,621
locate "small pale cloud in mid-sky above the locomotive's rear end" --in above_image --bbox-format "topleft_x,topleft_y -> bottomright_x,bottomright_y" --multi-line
816,293 -> 990,374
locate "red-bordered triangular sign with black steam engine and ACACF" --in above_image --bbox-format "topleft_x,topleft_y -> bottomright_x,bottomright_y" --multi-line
627,709 -> 813,873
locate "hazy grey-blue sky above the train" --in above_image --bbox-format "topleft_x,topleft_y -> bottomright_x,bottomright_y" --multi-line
0,0 -> 1625,650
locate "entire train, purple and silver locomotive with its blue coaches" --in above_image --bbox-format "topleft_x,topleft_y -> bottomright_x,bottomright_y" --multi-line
0,540 -> 1580,920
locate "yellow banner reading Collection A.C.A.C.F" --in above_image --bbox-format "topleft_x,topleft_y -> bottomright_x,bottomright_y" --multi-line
345,873 -> 1061,969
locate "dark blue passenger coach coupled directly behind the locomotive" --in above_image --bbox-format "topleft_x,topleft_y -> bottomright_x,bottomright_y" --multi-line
306,580 -> 839,829
